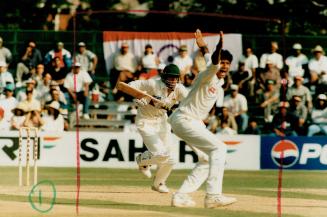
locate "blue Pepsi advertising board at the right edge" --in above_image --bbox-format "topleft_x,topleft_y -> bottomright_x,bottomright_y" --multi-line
260,136 -> 327,170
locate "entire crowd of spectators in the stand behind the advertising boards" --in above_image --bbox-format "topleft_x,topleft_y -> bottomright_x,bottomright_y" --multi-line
0,38 -> 327,136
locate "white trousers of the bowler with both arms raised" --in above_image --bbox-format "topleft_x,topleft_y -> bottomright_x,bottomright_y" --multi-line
169,111 -> 227,194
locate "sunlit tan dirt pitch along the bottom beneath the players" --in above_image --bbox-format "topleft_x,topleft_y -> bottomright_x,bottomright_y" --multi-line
0,186 -> 327,217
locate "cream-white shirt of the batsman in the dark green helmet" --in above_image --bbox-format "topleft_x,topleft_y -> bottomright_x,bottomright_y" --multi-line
129,78 -> 188,119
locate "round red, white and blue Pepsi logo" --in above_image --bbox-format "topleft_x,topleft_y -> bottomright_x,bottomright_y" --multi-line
271,140 -> 300,168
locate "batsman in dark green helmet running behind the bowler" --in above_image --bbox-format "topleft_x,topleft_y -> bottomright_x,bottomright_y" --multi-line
129,64 -> 188,193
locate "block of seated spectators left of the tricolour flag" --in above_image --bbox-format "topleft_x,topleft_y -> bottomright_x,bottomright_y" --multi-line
0,38 -> 98,132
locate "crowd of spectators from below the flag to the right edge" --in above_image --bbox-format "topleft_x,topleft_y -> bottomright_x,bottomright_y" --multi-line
110,41 -> 327,136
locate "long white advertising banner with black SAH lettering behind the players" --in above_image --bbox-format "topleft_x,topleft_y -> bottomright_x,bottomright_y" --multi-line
0,132 -> 260,170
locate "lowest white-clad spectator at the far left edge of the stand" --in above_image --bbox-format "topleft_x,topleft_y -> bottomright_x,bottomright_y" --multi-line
0,83 -> 17,124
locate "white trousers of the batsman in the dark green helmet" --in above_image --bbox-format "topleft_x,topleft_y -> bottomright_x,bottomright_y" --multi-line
135,116 -> 175,186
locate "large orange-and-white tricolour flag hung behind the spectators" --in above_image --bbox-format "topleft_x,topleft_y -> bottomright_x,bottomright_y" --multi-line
103,31 -> 242,74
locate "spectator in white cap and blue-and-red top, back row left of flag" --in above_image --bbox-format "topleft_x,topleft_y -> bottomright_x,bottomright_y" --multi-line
44,41 -> 72,70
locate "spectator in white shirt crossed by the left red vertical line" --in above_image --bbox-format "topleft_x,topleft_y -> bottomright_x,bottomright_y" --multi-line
64,62 -> 92,119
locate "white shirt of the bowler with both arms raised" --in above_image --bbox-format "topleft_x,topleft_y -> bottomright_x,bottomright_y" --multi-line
178,64 -> 224,120
